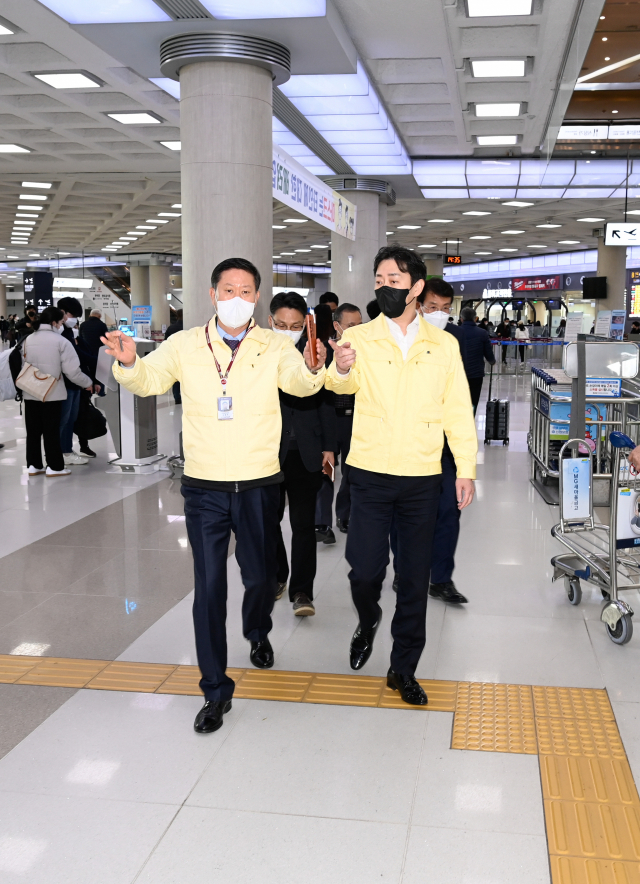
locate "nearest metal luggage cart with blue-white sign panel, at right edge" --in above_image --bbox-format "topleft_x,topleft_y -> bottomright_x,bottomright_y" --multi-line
551,432 -> 640,645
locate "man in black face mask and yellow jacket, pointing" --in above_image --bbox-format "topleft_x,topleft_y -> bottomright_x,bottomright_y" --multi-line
326,246 -> 478,706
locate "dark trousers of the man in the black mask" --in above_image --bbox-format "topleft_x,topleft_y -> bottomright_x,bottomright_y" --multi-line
346,467 -> 441,675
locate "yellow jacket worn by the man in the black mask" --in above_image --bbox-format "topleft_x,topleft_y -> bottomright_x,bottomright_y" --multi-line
326,314 -> 478,479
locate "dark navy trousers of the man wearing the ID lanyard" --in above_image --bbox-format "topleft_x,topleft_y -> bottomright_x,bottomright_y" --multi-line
182,485 -> 280,702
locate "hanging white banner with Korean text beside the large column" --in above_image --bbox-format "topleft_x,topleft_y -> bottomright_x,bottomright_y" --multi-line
271,144 -> 357,240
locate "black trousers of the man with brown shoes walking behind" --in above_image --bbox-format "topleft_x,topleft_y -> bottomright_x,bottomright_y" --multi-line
278,448 -> 322,601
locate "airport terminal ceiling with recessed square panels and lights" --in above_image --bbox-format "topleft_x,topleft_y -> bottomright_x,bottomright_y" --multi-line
0,0 -> 640,280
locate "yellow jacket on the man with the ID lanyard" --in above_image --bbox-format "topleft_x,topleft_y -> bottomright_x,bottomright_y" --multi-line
113,318 -> 325,482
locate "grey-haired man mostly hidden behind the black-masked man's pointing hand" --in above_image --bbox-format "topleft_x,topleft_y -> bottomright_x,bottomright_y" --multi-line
316,304 -> 362,543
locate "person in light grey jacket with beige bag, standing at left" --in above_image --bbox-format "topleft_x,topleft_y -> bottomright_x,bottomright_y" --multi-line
20,307 -> 93,478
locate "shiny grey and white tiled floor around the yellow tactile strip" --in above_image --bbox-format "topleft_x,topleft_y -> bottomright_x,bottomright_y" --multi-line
0,377 -> 640,884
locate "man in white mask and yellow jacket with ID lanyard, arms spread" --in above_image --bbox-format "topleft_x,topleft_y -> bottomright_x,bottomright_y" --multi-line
102,258 -> 326,733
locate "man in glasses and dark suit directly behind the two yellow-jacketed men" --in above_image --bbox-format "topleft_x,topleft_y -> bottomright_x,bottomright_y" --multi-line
269,292 -> 337,617
